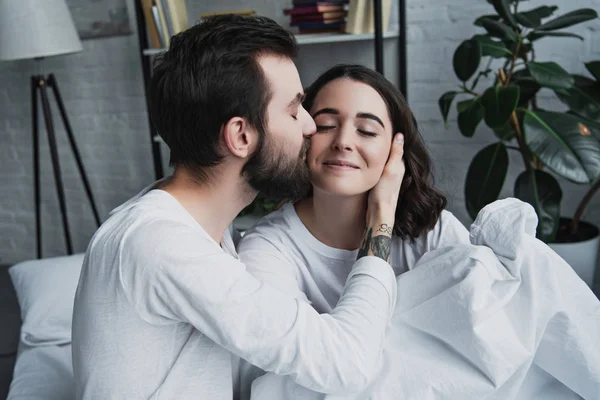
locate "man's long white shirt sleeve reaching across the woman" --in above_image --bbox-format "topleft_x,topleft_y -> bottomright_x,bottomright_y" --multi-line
120,226 -> 396,394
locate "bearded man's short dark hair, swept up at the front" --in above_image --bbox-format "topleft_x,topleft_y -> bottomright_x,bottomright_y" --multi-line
148,15 -> 297,180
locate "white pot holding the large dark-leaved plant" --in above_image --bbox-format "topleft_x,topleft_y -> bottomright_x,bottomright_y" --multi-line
548,218 -> 600,287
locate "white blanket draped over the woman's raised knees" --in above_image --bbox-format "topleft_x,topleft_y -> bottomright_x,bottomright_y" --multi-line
252,199 -> 600,400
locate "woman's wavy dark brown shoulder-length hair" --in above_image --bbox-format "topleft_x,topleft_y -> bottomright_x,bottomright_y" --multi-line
303,64 -> 447,240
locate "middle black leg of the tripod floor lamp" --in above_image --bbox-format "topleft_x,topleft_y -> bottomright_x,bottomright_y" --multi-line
39,80 -> 73,254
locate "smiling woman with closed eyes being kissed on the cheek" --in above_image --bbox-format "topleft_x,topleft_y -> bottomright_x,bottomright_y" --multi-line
238,65 -> 469,392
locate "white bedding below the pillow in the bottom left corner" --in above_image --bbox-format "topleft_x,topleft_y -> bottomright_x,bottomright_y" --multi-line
7,342 -> 75,400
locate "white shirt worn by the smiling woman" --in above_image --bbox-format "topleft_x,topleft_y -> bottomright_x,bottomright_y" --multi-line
238,204 -> 469,398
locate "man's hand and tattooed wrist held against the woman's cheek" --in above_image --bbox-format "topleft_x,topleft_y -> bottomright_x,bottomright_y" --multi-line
357,133 -> 406,263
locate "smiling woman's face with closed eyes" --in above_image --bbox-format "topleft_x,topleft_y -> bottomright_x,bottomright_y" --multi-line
307,78 -> 392,196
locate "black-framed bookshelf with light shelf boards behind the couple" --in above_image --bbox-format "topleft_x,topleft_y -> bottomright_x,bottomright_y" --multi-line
134,0 -> 407,180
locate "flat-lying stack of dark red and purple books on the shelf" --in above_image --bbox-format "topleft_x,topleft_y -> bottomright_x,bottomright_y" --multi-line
283,0 -> 349,33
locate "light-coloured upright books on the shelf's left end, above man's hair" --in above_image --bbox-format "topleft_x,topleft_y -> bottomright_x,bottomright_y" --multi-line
140,0 -> 189,48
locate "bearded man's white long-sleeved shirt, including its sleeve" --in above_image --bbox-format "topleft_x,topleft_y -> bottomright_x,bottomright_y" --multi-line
72,187 -> 397,400
